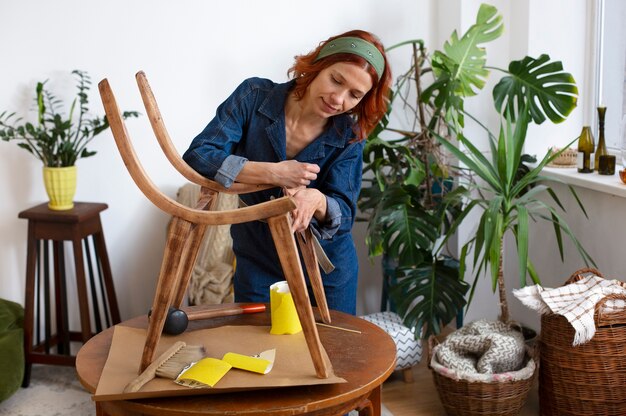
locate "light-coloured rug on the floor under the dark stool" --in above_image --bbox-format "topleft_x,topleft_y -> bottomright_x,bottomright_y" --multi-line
0,364 -> 393,416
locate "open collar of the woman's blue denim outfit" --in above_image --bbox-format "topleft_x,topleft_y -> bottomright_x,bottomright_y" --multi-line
259,80 -> 353,161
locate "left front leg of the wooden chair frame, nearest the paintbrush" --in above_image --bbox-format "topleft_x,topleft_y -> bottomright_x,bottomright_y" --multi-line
139,217 -> 192,372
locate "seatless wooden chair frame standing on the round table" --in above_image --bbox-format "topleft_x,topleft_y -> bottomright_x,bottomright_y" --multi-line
98,71 -> 330,378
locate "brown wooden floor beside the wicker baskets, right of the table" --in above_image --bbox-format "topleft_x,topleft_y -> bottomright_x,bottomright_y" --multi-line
383,359 -> 539,416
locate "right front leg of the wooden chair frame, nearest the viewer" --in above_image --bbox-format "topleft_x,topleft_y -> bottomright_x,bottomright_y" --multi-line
267,214 -> 329,378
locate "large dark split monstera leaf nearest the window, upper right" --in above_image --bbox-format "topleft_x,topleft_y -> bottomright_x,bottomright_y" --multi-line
493,54 -> 578,124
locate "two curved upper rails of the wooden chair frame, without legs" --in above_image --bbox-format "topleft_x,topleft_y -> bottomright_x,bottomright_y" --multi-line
98,76 -> 295,225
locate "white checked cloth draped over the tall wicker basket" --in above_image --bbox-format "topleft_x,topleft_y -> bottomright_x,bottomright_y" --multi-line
513,275 -> 626,345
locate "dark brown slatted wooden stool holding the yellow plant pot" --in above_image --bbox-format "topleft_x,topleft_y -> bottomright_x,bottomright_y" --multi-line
18,202 -> 120,387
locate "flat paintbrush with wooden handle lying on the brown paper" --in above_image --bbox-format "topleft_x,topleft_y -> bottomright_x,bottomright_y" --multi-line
124,341 -> 204,393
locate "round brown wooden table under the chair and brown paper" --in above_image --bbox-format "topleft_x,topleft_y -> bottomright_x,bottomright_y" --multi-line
76,307 -> 396,416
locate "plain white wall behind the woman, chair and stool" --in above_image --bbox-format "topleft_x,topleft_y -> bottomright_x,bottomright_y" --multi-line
0,0 -> 431,318
